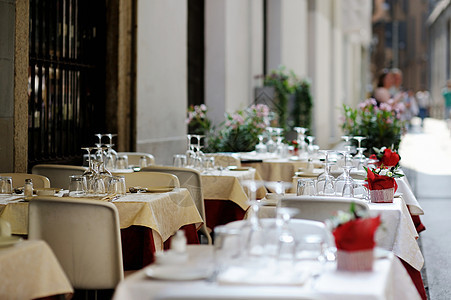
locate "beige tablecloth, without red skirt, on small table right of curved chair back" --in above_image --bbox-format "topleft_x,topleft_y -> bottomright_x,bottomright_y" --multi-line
202,168 -> 266,210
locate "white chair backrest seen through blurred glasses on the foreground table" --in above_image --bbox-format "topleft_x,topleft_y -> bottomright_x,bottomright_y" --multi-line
225,218 -> 333,246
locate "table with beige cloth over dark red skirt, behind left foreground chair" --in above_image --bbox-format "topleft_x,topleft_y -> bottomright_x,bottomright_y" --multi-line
0,188 -> 203,270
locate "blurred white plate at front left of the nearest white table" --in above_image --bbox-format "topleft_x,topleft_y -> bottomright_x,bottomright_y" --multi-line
146,265 -> 210,280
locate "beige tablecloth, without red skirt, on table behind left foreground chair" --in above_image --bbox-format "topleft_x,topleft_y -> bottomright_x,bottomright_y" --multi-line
0,188 -> 202,251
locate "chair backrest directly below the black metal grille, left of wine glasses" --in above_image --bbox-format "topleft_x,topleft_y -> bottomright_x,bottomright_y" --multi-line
31,164 -> 87,190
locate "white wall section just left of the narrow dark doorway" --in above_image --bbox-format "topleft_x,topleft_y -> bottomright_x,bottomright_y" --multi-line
136,0 -> 187,164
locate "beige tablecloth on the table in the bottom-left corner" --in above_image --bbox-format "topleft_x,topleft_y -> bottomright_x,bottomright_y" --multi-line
0,240 -> 73,300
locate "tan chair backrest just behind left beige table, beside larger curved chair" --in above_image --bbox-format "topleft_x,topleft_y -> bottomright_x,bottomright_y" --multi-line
118,172 -> 180,190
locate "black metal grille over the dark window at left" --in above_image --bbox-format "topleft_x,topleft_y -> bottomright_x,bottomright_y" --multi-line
28,0 -> 106,168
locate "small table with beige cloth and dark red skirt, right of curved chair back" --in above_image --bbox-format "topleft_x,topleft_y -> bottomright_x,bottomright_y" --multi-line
202,168 -> 266,229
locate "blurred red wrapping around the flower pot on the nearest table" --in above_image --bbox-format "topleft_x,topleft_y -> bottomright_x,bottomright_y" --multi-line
332,216 -> 381,251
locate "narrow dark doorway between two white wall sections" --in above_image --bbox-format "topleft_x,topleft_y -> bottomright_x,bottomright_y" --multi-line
188,0 -> 205,105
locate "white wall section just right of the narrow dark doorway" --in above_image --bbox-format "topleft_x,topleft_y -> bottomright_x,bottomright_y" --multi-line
205,0 -> 263,124
